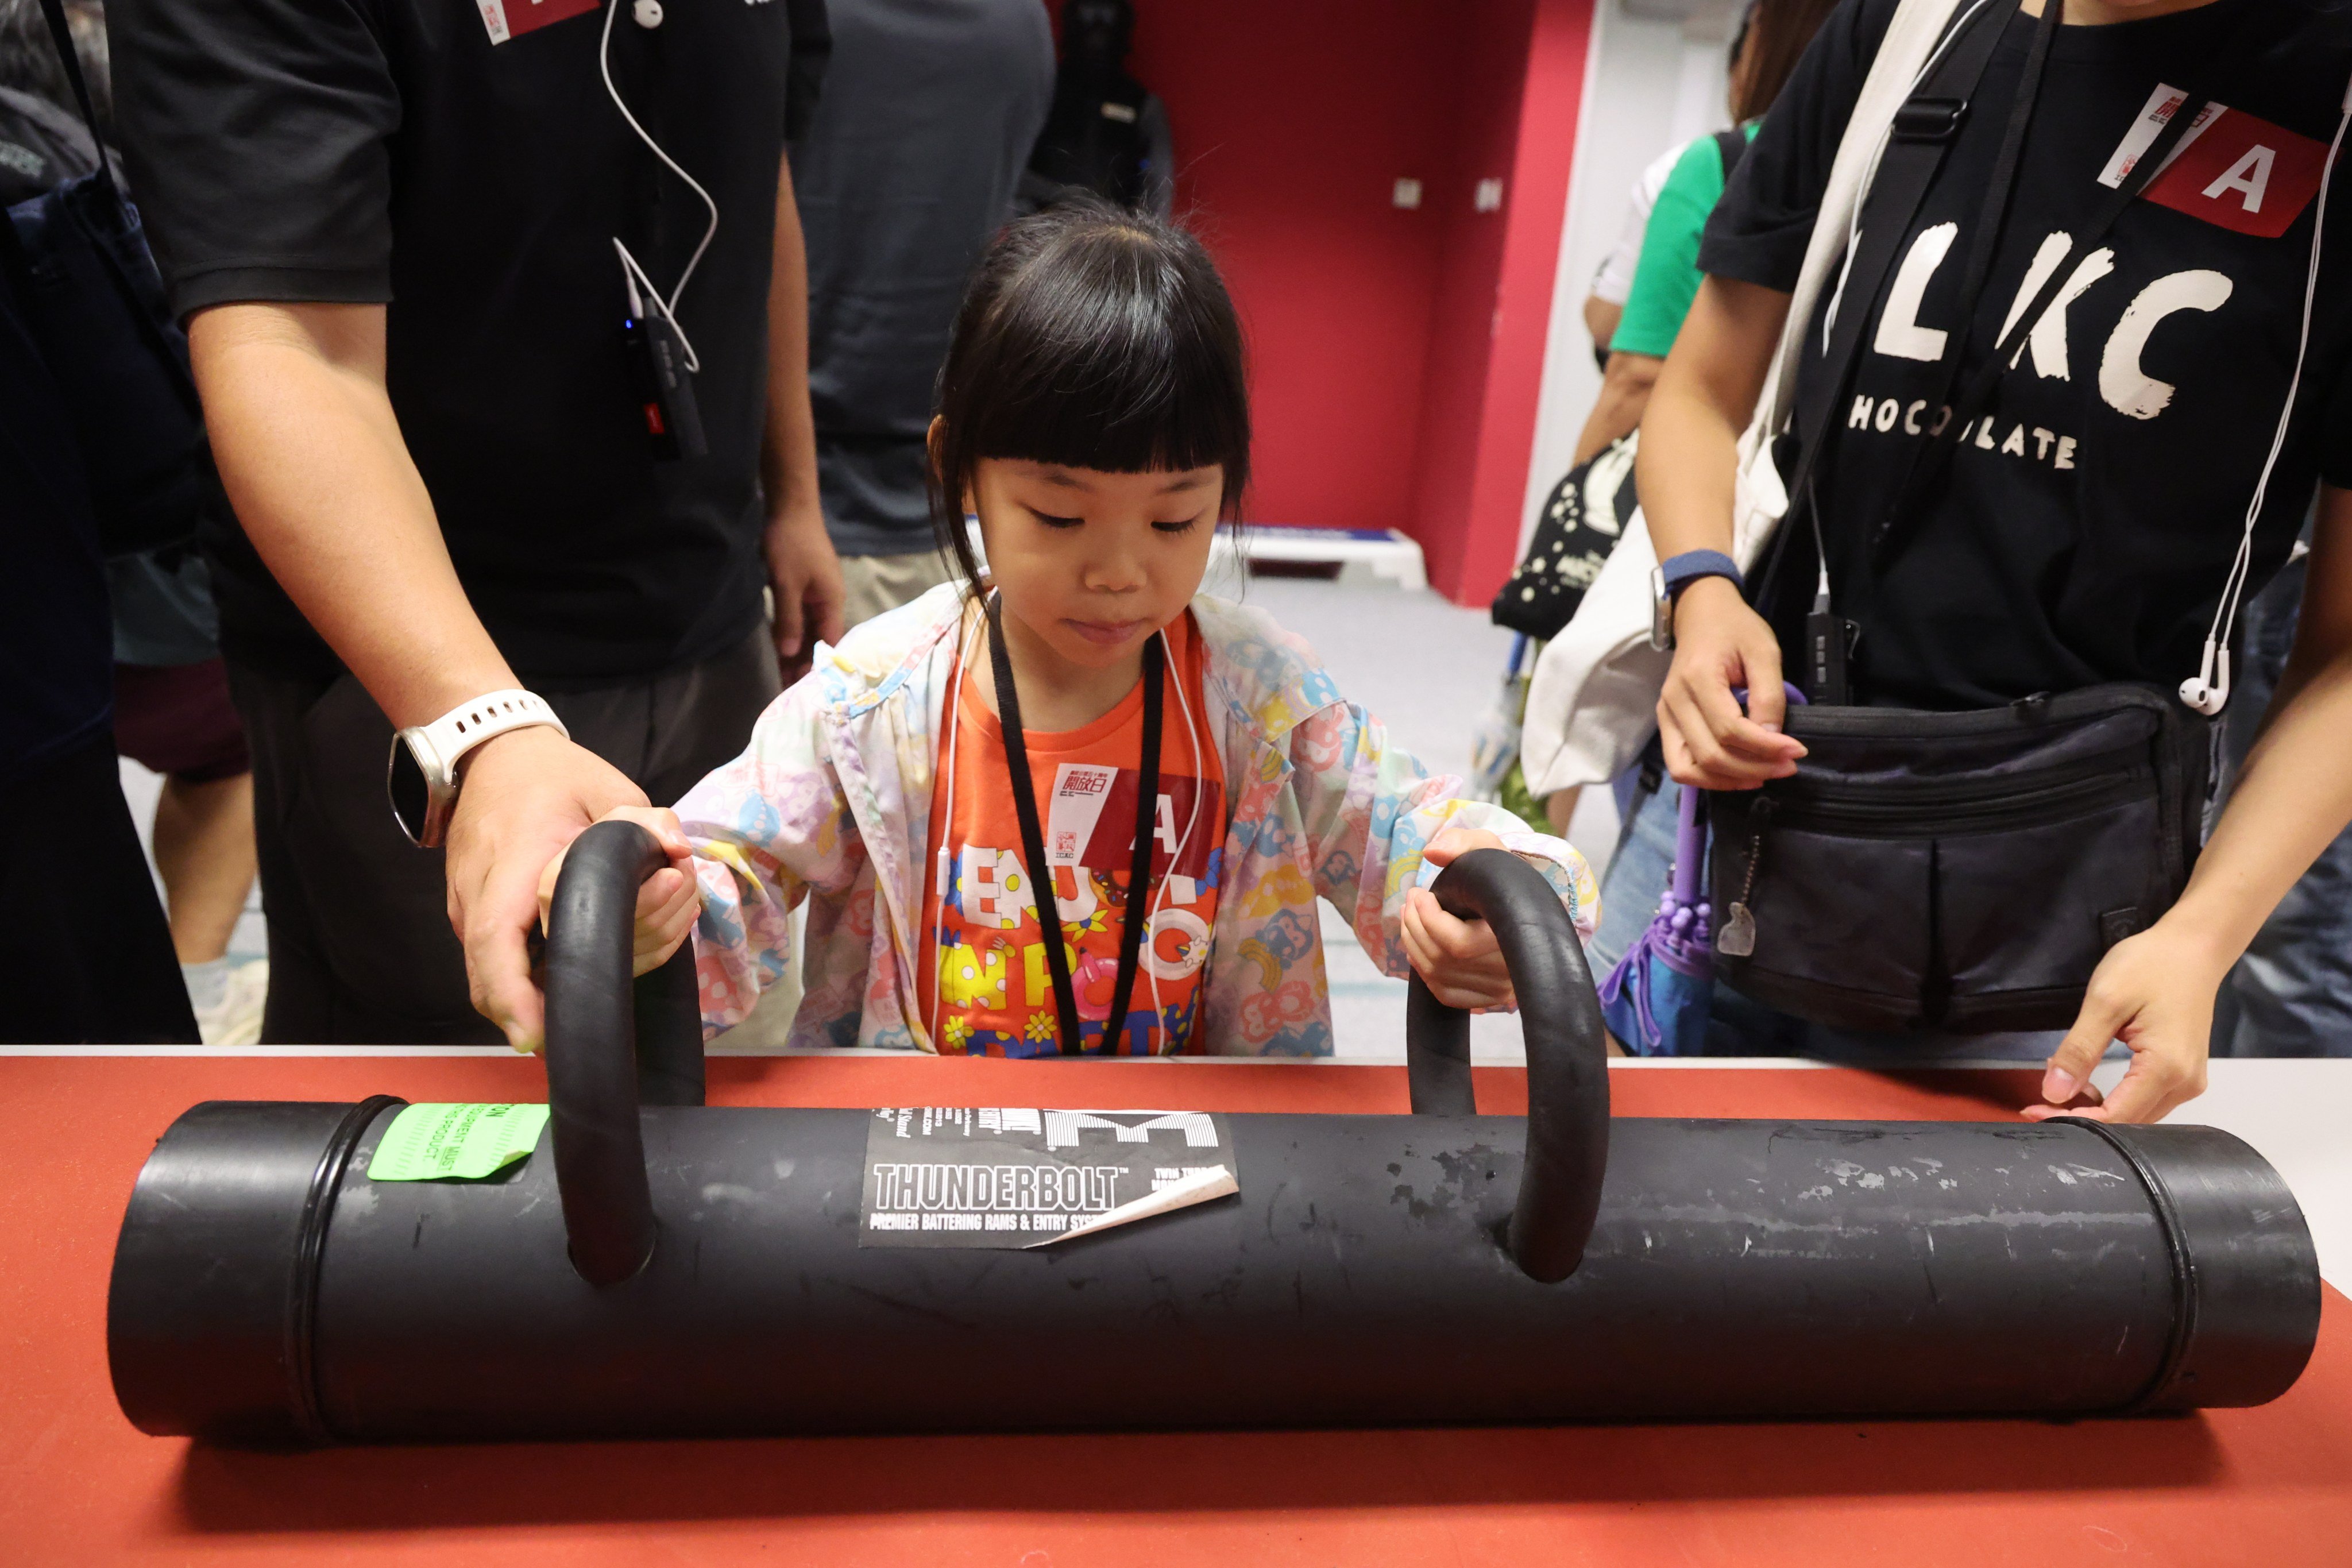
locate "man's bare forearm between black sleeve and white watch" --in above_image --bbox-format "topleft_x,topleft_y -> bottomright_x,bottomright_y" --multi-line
188,306 -> 515,727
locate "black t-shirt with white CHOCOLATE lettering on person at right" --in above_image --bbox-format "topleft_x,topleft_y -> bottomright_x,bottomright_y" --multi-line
1698,0 -> 2352,708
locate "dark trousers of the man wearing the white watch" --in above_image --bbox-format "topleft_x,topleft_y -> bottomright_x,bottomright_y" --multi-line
228,625 -> 778,1046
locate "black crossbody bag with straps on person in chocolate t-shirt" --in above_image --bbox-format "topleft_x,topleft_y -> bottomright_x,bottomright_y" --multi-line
1708,0 -> 2239,1032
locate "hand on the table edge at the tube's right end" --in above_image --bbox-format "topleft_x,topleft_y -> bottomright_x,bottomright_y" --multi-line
2025,919 -> 2230,1121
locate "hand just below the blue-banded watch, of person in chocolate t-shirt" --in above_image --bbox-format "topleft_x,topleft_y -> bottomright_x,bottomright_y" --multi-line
1658,578 -> 1804,790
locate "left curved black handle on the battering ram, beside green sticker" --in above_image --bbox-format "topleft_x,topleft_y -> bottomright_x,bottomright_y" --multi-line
546,823 -> 703,1286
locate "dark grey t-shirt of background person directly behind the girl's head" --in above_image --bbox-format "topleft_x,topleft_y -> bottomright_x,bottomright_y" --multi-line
793,0 -> 1054,555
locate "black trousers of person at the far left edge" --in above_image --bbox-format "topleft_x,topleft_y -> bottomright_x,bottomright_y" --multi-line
0,731 -> 198,1046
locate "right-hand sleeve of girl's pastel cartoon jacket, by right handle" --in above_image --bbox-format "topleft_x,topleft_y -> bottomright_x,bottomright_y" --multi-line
1289,703 -> 1600,978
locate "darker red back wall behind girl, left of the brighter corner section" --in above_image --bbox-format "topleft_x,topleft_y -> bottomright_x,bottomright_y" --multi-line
1131,0 -> 1484,531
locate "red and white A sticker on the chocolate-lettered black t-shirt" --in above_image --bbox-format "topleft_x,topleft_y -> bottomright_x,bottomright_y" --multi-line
2098,87 -> 2328,240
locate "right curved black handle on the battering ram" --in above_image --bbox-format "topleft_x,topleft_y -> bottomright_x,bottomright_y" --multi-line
1404,849 -> 1609,1281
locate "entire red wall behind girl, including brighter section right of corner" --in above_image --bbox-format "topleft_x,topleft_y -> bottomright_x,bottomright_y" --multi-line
1119,0 -> 1592,602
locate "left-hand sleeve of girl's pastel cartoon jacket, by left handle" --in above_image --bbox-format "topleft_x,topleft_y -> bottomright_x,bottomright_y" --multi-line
677,675 -> 866,1032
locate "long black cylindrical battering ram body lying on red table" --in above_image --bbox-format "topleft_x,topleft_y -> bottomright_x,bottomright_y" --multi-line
110,1105 -> 2319,1441
